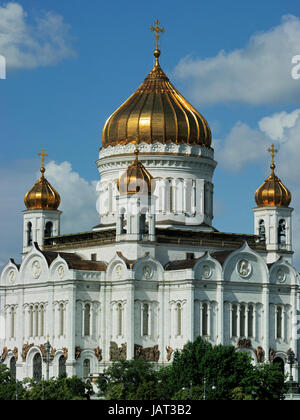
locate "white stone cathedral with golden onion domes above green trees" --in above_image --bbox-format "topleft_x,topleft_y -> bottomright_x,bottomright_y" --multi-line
0,28 -> 299,380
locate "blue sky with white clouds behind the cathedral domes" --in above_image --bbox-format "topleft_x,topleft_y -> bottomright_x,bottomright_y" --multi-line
0,0 -> 300,263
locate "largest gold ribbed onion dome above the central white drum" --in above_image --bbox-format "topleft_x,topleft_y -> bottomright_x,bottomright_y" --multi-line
102,49 -> 211,147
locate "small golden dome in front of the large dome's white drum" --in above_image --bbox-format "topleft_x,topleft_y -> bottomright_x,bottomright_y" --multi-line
117,149 -> 155,195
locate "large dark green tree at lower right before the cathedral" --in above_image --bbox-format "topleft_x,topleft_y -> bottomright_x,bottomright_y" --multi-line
159,337 -> 285,400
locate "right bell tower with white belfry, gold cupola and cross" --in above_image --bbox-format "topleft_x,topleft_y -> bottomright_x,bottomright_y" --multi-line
253,144 -> 293,263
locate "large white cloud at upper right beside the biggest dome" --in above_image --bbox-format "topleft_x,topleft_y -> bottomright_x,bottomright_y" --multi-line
175,15 -> 300,105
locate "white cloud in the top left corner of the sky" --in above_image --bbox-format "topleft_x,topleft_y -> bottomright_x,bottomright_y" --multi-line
0,2 -> 76,69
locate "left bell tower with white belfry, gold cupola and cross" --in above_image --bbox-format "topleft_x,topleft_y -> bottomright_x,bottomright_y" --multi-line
23,149 -> 62,254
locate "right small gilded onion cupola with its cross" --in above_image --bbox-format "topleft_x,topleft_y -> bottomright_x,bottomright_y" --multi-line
255,144 -> 292,207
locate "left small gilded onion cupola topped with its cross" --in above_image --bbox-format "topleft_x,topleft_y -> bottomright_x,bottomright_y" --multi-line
24,149 -> 60,210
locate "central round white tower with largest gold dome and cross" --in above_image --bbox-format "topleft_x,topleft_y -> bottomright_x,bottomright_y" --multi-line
97,22 -> 217,231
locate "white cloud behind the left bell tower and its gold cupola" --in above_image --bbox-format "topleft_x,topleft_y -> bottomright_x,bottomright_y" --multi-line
0,160 -> 99,269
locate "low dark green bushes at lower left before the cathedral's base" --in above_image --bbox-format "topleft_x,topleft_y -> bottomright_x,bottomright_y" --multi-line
23,376 -> 93,400
